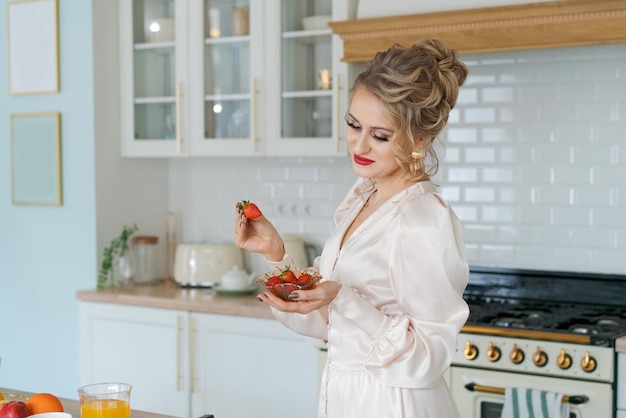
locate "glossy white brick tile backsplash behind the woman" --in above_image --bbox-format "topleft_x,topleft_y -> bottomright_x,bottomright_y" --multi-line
169,44 -> 626,274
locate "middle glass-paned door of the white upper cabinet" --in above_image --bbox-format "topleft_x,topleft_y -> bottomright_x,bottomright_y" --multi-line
190,0 -> 263,155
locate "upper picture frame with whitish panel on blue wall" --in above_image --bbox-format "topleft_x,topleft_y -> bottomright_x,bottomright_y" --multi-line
7,0 -> 59,95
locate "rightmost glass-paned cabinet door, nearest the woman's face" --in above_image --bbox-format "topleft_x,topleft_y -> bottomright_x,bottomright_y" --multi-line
266,0 -> 346,156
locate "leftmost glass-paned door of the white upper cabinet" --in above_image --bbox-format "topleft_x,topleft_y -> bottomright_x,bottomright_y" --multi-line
120,0 -> 186,156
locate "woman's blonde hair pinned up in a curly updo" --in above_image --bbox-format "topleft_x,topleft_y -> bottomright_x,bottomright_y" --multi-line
351,39 -> 468,181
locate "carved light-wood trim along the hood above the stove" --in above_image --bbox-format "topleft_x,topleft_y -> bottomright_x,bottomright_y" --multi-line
329,0 -> 626,62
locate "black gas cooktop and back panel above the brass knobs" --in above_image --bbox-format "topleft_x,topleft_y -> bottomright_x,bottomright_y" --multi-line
464,267 -> 626,346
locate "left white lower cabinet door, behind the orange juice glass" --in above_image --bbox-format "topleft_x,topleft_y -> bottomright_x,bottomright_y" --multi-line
79,302 -> 189,417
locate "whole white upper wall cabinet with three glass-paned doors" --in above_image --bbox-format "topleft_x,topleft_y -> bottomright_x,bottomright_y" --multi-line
119,0 -> 355,157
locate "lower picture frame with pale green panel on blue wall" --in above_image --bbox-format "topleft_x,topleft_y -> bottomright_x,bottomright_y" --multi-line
11,112 -> 62,206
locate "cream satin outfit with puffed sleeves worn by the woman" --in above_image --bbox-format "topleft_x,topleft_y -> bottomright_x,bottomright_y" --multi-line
270,179 -> 469,418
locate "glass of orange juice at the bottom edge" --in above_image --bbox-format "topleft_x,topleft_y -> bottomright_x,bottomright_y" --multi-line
78,383 -> 132,418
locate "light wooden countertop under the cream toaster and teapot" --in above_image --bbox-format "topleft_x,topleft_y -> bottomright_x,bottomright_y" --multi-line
76,281 -> 274,318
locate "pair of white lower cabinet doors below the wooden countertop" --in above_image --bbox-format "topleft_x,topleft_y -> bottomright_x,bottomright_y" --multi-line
79,301 -> 319,418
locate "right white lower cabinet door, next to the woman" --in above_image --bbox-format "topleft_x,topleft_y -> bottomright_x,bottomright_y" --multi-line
190,313 -> 319,418
